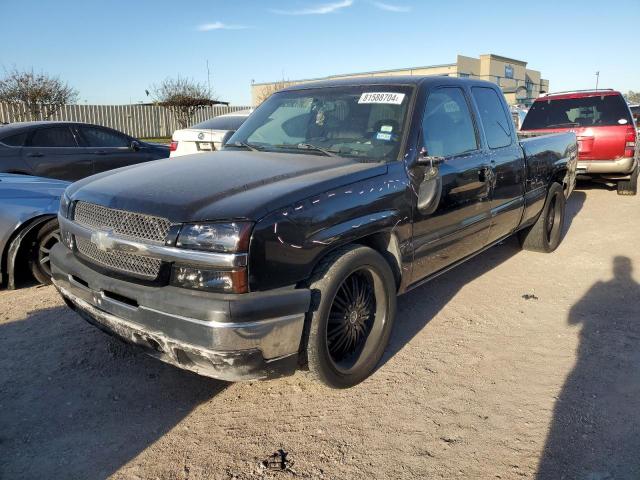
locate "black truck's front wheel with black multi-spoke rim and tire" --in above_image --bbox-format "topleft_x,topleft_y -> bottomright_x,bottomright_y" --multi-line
306,245 -> 396,388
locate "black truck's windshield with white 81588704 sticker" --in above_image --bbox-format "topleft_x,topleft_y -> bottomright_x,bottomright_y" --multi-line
225,85 -> 412,161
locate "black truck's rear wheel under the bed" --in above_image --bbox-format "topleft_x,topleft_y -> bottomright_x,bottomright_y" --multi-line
518,183 -> 566,253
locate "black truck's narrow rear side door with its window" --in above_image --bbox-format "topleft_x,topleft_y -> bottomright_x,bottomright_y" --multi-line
471,87 -> 526,243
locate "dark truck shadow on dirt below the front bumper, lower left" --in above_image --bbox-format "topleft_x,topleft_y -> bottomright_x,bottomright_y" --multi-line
0,307 -> 227,478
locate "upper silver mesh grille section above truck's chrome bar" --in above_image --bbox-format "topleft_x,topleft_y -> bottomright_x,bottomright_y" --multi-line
73,202 -> 171,244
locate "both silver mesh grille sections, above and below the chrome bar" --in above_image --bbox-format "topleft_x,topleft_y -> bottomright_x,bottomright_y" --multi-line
73,201 -> 171,279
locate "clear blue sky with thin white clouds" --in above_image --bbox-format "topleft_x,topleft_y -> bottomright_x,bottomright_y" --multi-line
0,0 -> 640,104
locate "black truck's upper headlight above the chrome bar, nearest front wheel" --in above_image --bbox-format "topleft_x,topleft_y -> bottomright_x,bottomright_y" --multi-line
176,222 -> 252,253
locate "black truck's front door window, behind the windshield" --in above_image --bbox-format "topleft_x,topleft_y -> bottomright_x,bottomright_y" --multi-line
422,87 -> 478,157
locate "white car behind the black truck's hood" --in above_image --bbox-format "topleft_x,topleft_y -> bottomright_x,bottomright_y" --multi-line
169,110 -> 251,157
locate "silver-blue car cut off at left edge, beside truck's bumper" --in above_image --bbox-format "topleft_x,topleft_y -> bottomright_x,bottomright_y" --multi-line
0,173 -> 69,289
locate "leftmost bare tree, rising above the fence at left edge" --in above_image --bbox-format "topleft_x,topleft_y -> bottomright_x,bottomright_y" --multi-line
0,68 -> 78,121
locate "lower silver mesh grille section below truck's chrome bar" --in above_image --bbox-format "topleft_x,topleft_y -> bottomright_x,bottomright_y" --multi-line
76,237 -> 162,280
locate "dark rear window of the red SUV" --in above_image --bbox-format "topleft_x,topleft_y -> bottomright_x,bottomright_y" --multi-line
522,95 -> 631,130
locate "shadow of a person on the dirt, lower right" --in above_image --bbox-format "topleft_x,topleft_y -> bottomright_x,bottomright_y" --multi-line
537,257 -> 640,480
